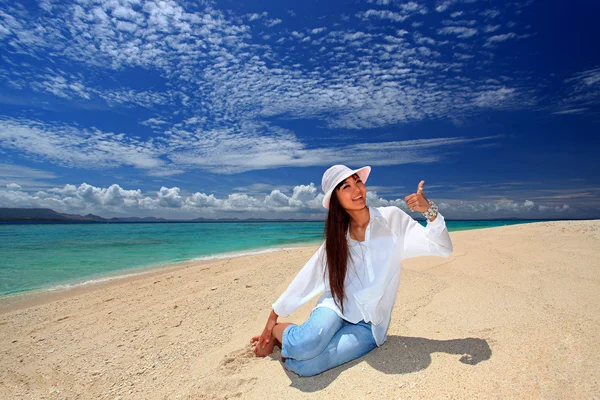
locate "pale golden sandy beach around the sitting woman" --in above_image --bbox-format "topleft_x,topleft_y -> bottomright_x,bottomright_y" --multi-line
0,220 -> 600,399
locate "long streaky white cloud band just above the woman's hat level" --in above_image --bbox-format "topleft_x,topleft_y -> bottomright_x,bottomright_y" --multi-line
0,119 -> 506,176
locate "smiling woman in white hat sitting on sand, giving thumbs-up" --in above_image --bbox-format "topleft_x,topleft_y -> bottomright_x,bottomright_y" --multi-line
251,165 -> 452,376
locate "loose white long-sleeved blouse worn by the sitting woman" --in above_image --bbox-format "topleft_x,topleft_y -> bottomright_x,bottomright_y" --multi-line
273,207 -> 452,346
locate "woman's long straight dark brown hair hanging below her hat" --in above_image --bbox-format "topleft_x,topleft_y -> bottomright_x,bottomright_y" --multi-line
324,182 -> 350,312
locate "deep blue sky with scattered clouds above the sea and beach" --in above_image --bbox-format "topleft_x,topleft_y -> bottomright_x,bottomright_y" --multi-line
0,0 -> 600,219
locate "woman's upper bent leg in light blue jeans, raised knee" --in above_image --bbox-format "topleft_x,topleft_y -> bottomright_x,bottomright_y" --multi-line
281,307 -> 344,362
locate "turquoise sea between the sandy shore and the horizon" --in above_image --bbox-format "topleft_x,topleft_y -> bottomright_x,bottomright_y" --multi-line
0,221 -> 548,296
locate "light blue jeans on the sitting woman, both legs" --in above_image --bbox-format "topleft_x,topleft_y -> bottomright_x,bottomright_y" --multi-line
281,307 -> 377,376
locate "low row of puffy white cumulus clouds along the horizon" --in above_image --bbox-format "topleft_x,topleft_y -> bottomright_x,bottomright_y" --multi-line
0,183 -> 576,219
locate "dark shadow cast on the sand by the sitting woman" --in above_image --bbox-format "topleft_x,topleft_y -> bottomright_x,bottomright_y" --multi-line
285,336 -> 492,392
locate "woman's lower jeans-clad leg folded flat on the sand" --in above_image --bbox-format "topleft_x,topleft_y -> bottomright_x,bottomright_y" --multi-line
282,321 -> 377,376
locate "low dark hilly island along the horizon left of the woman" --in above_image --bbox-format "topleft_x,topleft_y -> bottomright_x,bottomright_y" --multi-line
0,208 -> 323,223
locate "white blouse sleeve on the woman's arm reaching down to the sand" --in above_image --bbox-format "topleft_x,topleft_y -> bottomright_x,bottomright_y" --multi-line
273,243 -> 326,318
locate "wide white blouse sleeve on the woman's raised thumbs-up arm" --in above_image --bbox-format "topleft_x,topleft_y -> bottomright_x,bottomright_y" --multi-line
400,210 -> 453,259
